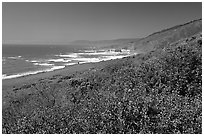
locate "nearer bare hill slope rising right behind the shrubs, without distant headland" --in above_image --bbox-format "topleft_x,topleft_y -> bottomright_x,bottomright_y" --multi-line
131,19 -> 202,52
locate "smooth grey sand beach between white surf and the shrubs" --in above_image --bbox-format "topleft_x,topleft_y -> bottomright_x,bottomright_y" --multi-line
2,59 -> 120,108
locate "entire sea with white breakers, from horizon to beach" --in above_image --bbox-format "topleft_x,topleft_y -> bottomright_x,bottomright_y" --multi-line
2,45 -> 132,79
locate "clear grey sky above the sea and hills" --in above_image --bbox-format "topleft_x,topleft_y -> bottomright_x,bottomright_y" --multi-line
2,2 -> 202,43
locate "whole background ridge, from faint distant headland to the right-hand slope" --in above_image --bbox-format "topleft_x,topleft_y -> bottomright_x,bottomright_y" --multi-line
70,19 -> 202,52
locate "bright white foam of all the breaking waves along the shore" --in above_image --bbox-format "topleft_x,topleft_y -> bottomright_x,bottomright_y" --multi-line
2,50 -> 135,80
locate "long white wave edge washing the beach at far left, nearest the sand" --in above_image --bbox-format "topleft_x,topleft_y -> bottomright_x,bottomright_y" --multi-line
2,66 -> 65,80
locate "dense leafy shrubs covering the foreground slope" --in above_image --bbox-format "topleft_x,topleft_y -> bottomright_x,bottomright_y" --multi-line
2,36 -> 202,134
